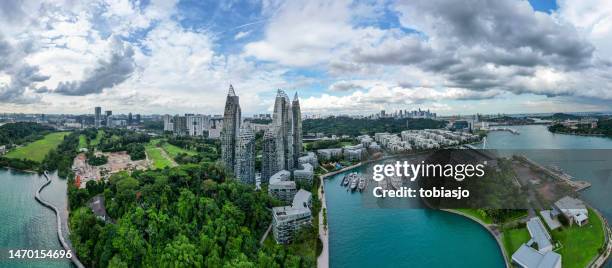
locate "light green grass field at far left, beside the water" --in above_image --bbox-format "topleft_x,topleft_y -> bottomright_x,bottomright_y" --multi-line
6,132 -> 70,163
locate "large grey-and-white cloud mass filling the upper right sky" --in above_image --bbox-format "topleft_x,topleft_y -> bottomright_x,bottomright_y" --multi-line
340,0 -> 611,98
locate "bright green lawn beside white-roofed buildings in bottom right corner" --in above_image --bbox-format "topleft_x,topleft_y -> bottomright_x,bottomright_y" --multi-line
552,209 -> 605,268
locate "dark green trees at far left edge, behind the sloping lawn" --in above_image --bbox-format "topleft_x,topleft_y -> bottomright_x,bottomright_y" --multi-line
0,122 -> 53,145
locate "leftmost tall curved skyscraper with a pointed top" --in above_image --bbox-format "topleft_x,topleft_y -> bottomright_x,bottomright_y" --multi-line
221,85 -> 241,174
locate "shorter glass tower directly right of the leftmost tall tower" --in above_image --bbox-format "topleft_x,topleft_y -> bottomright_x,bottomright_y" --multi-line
234,127 -> 255,184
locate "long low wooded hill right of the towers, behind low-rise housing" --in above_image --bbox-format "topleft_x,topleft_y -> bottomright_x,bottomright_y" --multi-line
302,116 -> 446,136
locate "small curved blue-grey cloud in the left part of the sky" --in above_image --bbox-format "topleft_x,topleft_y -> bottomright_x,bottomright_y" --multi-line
53,40 -> 135,96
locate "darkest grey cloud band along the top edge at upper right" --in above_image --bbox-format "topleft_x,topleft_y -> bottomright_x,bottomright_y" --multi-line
398,0 -> 594,68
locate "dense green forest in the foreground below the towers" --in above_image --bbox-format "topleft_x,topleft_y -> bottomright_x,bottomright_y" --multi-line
68,163 -> 316,267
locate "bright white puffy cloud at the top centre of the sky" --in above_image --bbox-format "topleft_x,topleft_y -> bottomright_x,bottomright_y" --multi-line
244,0 -> 354,66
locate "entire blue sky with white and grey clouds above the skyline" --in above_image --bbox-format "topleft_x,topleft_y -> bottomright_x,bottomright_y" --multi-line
0,0 -> 612,114
